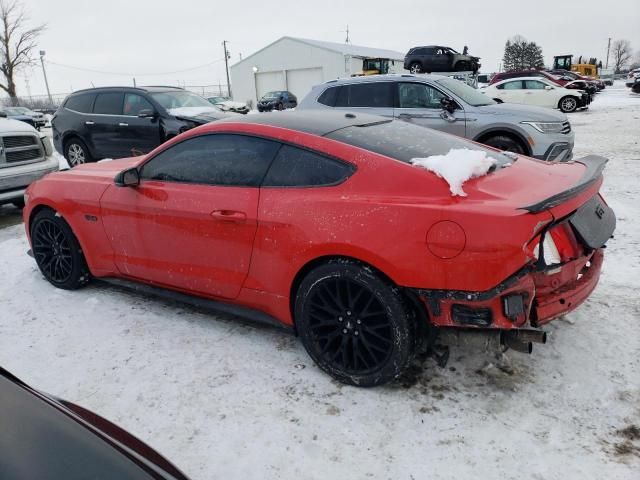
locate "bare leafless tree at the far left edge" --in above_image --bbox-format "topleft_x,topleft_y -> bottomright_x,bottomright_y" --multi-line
0,0 -> 46,104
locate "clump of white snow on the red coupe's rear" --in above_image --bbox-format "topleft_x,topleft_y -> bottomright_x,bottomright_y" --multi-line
411,148 -> 496,197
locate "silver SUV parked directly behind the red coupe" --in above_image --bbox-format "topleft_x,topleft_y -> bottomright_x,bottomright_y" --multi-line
298,75 -> 574,161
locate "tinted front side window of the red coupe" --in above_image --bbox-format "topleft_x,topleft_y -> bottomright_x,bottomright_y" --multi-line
140,134 -> 280,187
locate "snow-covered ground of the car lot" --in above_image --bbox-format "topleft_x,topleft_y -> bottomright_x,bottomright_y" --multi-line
0,80 -> 640,480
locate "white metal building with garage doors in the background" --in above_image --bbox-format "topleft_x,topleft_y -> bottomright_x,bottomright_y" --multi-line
231,37 -> 406,107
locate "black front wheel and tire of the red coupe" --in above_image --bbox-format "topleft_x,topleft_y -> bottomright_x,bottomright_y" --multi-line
31,209 -> 89,290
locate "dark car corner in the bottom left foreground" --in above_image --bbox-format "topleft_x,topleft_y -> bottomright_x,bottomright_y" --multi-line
0,368 -> 188,480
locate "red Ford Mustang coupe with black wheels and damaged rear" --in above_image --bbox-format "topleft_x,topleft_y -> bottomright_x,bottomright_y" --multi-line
24,112 -> 615,386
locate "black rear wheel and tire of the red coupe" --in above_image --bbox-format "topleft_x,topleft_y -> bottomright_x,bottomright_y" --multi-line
295,259 -> 416,387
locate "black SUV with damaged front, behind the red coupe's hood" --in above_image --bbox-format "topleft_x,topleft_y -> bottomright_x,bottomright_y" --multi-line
51,87 -> 229,167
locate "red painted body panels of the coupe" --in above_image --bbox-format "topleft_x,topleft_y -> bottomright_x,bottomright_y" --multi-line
24,118 -> 602,328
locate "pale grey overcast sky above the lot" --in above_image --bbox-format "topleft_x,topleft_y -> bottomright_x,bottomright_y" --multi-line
13,0 -> 640,99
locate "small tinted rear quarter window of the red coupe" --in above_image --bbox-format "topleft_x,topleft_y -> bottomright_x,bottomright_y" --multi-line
262,145 -> 355,187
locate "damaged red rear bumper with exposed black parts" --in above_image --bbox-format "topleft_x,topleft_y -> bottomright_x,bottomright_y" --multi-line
414,249 -> 604,329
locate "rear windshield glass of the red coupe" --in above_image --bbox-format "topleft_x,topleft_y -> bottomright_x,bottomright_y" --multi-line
325,120 -> 513,168
